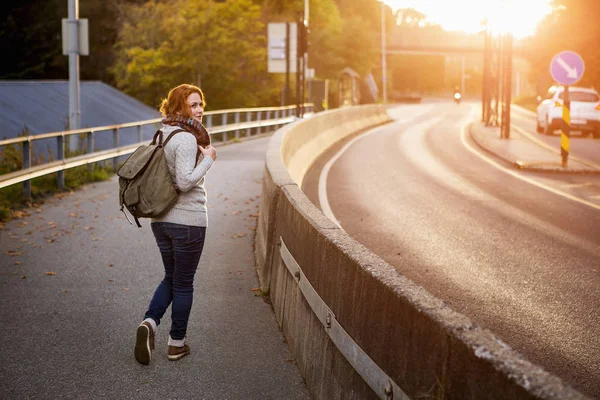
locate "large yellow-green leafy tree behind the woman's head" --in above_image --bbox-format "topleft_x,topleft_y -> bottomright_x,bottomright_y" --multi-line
112,0 -> 278,109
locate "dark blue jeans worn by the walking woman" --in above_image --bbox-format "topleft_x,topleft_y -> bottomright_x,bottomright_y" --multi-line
144,222 -> 206,340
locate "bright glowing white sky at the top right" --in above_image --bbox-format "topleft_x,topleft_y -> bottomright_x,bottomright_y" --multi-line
384,0 -> 552,38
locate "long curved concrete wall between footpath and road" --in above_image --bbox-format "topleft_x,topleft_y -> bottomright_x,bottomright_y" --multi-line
255,105 -> 585,400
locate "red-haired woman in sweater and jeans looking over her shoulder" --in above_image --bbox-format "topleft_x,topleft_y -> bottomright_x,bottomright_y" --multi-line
134,84 -> 217,365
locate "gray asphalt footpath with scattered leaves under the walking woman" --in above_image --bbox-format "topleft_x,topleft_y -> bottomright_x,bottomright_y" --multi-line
0,138 -> 311,400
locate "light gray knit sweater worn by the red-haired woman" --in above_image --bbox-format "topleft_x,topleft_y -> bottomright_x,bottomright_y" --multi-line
152,125 -> 213,226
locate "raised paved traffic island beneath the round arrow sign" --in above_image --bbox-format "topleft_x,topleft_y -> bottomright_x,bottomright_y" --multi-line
468,121 -> 600,174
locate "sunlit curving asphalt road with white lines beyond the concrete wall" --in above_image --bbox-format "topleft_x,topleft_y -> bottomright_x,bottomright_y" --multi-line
304,102 -> 600,398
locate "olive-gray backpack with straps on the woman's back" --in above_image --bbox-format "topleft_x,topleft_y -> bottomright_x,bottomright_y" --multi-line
117,129 -> 185,228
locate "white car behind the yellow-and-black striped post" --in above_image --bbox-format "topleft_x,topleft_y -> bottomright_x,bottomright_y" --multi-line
536,86 -> 600,138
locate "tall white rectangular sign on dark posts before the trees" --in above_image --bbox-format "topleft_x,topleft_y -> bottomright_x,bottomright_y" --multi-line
267,22 -> 297,73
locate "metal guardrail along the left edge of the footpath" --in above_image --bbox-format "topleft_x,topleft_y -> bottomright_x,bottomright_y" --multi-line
0,103 -> 314,197
